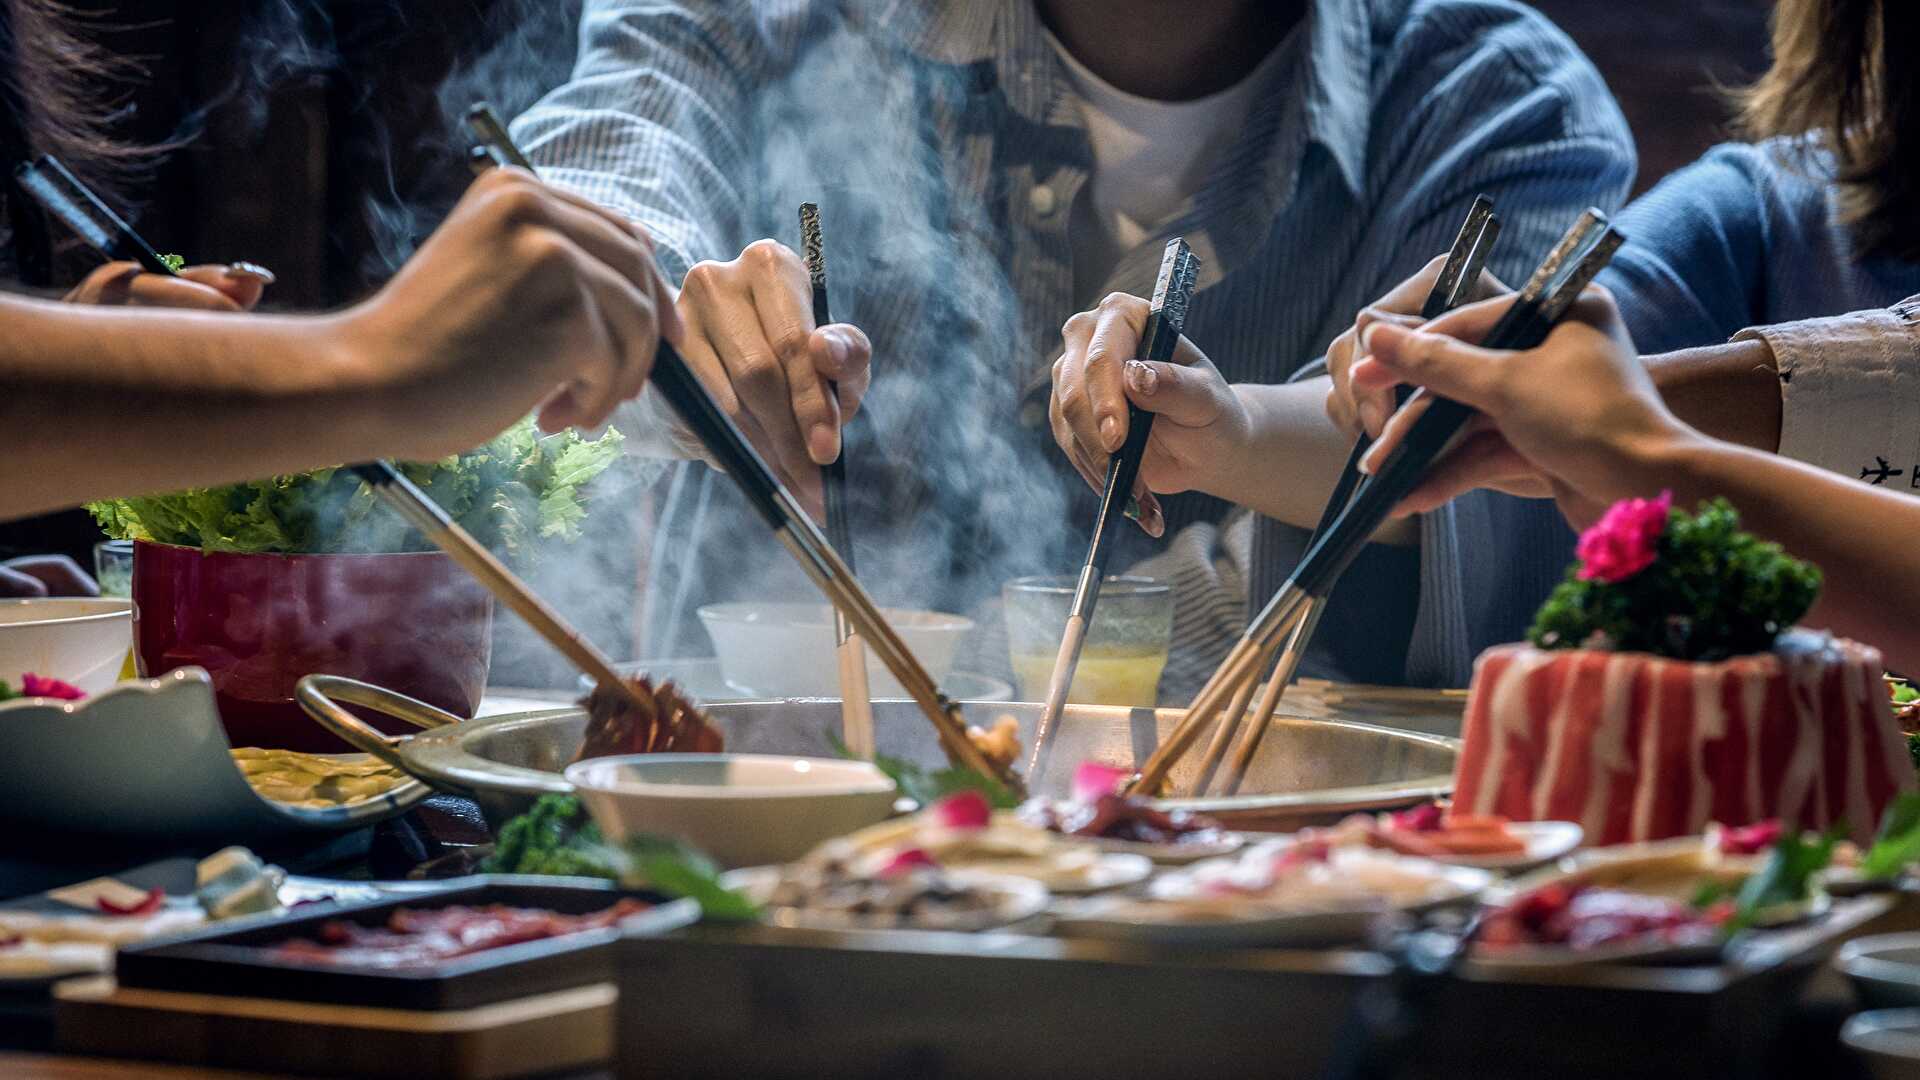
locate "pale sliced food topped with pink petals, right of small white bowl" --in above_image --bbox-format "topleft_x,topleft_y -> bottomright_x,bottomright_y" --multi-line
820,792 -> 1152,892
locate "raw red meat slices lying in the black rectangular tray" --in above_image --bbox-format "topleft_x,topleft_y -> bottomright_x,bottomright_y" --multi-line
273,897 -> 653,969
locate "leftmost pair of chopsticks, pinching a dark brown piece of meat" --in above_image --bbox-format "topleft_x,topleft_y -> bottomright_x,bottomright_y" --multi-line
19,147 -> 651,709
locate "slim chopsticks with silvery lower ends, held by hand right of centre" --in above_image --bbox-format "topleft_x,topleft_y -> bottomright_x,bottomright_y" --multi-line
1027,236 -> 1200,776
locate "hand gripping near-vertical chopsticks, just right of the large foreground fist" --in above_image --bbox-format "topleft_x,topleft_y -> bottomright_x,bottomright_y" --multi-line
678,240 -> 874,507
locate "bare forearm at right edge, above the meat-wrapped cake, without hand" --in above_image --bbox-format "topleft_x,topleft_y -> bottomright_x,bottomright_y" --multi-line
1638,430 -> 1920,671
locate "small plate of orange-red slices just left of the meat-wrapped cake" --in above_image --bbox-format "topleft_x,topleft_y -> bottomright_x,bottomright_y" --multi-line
1298,801 -> 1586,874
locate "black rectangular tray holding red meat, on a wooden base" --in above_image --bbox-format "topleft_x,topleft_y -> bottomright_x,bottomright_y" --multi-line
115,874 -> 699,1011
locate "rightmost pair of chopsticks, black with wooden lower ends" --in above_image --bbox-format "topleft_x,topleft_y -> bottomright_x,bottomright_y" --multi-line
1133,209 -> 1620,792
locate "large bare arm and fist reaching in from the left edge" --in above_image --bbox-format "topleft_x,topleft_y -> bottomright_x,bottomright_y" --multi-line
0,171 -> 680,519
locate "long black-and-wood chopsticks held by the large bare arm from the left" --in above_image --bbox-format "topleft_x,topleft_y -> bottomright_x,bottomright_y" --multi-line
468,102 -> 1023,792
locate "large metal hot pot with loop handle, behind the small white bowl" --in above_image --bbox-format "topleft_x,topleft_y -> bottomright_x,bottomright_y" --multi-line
301,676 -> 1459,832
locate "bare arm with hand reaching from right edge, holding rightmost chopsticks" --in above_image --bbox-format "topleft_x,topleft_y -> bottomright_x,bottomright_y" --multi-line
1354,292 -> 1920,667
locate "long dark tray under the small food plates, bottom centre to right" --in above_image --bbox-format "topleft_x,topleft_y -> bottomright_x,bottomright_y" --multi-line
618,897 -> 1893,1080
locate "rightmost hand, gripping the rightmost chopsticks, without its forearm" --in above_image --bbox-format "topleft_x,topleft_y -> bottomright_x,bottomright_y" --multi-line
1352,286 -> 1701,527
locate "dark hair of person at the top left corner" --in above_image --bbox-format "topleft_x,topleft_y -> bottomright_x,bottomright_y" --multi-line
0,0 -> 152,286
